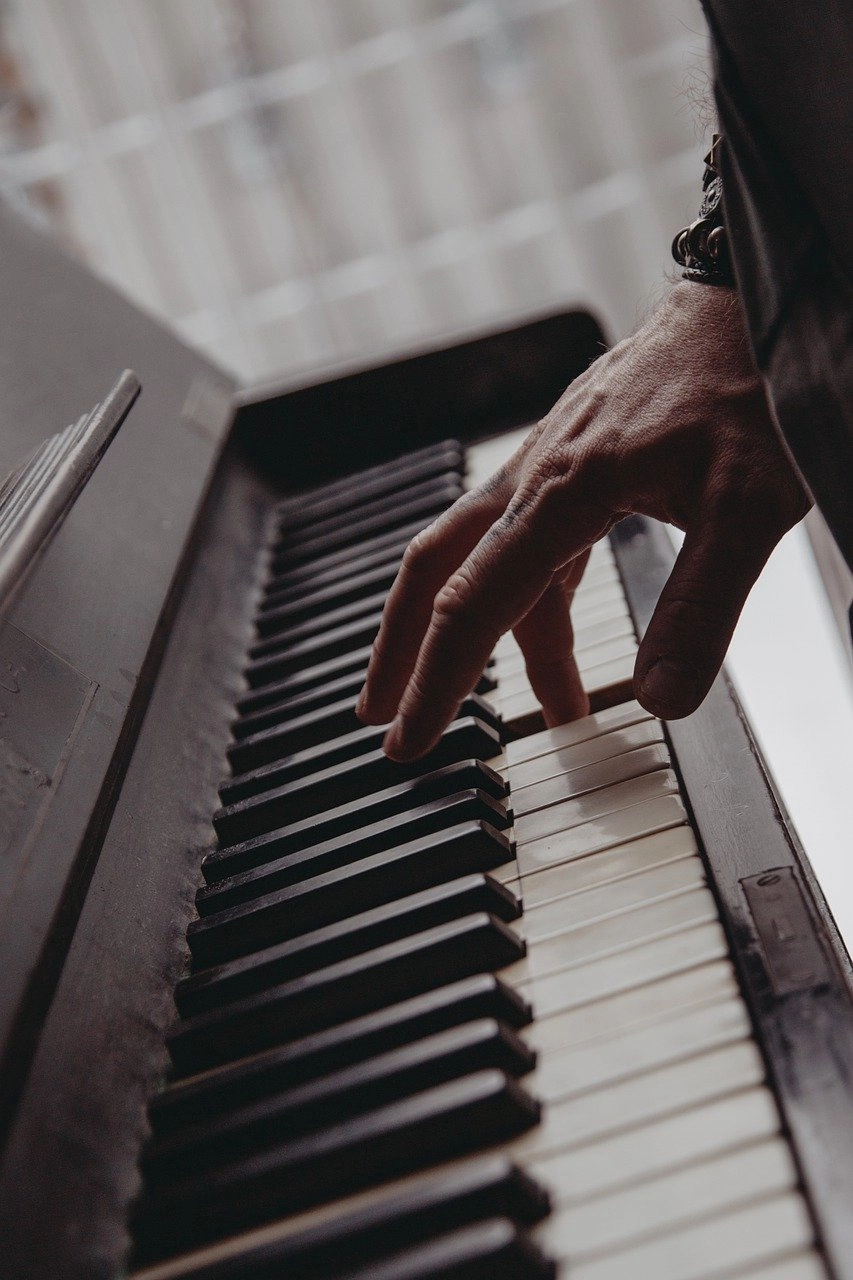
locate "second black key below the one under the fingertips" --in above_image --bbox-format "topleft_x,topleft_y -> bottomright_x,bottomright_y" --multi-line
196,791 -> 511,915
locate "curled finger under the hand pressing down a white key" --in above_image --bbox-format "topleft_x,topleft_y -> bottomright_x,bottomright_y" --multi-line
514,550 -> 589,728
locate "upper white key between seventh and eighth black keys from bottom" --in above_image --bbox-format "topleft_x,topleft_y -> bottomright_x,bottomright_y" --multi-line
516,792 -> 686,877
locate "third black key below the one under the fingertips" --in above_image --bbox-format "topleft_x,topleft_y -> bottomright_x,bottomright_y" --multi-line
187,822 -> 512,966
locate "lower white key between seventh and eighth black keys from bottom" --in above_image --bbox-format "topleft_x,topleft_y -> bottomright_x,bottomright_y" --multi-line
512,826 -> 697,908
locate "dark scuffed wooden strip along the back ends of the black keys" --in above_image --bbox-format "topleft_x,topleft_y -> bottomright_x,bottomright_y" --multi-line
0,448 -> 270,1280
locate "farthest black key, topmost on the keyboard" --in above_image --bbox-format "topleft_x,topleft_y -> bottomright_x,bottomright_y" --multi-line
277,440 -> 465,529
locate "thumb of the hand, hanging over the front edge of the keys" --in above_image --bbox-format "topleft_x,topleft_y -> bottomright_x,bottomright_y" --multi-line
634,521 -> 779,719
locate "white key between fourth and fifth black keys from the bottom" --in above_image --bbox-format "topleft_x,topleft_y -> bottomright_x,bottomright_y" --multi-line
524,957 -> 740,1056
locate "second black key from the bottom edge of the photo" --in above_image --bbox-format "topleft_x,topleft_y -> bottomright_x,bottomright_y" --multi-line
136,1156 -> 551,1280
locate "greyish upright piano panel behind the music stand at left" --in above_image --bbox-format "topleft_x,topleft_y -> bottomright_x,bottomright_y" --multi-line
0,206 -> 232,1138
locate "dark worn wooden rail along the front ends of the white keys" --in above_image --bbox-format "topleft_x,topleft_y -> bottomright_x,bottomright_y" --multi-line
611,517 -> 853,1280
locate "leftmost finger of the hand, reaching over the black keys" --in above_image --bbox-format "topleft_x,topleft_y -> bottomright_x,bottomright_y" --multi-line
356,484 -> 506,724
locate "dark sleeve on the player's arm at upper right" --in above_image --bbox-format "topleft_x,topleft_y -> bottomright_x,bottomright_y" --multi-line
703,0 -> 853,567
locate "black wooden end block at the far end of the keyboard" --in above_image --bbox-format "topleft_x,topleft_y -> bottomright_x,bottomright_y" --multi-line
236,311 -> 606,485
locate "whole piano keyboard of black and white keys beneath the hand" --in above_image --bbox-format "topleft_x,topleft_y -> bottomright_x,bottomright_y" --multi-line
134,444 -> 827,1280
